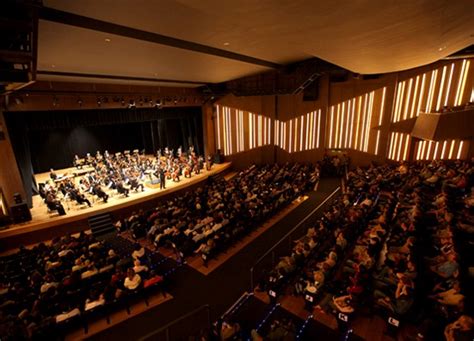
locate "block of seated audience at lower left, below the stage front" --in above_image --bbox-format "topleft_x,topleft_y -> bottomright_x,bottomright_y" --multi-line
0,233 -> 170,339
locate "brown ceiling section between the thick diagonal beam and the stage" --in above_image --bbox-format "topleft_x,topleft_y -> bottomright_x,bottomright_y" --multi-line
38,20 -> 266,83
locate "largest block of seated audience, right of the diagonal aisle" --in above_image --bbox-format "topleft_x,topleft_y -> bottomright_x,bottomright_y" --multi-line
252,162 -> 474,340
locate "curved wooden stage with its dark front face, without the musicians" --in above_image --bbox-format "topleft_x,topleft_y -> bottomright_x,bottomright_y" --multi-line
0,162 -> 231,251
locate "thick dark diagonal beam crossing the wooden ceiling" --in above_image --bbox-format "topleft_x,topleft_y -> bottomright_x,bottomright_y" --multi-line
39,7 -> 282,69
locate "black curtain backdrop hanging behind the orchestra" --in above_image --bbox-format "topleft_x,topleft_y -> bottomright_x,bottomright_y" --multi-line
5,107 -> 204,206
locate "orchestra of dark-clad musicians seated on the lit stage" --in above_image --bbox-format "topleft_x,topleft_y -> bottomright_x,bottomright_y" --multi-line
39,146 -> 210,214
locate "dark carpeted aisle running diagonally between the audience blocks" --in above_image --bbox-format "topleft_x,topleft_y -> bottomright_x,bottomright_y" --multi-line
91,178 -> 341,340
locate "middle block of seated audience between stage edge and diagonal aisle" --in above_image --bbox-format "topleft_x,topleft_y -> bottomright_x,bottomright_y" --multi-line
117,164 -> 319,264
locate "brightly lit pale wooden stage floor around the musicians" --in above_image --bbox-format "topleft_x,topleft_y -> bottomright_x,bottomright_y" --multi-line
0,162 -> 231,239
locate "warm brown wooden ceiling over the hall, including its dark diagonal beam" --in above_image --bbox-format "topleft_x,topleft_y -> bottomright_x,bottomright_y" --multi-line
38,0 -> 474,87
